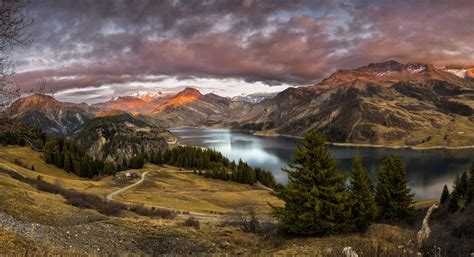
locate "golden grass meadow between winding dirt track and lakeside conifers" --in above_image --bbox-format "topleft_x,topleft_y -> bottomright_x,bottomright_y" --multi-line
116,165 -> 282,214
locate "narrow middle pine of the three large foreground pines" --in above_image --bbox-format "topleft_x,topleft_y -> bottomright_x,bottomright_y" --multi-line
349,154 -> 377,232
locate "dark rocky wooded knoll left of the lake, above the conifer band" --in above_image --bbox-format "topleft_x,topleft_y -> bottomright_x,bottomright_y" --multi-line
75,113 -> 176,166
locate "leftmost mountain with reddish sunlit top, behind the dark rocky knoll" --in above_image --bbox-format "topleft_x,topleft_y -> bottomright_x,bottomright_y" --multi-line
4,94 -> 98,137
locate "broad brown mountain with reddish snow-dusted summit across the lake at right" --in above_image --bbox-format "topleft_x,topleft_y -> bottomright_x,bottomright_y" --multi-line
229,61 -> 474,146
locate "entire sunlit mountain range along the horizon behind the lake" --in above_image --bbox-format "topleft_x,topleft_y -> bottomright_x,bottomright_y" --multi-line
5,61 -> 474,147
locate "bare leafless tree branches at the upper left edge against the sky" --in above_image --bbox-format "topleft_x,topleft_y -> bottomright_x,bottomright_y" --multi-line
0,0 -> 33,110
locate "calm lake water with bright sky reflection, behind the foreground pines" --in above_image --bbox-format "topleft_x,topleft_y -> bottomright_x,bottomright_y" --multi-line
171,128 -> 474,199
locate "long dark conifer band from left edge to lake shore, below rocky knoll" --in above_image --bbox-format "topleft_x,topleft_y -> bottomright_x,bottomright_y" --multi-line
0,121 -> 277,188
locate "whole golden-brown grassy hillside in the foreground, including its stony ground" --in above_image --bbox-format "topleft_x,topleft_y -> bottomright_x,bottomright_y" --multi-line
0,147 -> 428,256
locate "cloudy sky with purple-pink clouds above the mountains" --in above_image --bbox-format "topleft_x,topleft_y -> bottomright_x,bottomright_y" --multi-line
14,0 -> 474,102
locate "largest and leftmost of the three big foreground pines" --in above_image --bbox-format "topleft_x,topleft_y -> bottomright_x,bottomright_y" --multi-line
272,131 -> 350,235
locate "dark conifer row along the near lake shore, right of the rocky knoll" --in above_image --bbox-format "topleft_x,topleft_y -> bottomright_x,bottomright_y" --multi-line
150,146 -> 277,188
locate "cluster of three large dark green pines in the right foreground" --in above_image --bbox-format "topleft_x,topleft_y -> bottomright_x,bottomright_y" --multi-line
272,131 -> 414,236
